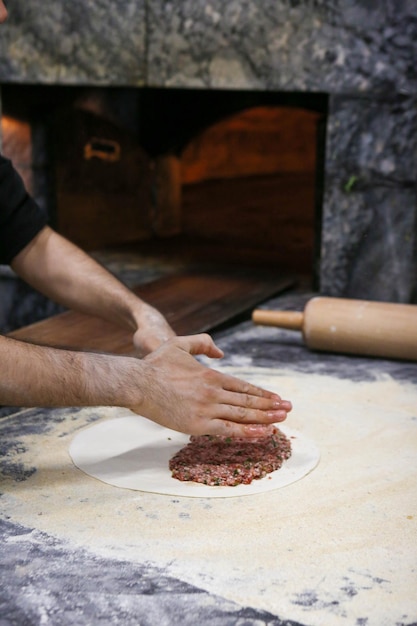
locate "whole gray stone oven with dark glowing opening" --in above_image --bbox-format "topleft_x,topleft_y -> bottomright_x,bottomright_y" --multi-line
0,0 -> 417,332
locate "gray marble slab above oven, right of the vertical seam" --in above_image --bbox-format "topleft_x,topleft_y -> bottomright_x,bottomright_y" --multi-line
148,0 -> 417,94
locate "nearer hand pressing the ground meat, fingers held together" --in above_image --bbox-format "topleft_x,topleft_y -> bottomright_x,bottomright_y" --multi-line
129,334 -> 292,437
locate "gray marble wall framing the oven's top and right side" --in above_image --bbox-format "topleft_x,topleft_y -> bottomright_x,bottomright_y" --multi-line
0,0 -> 417,302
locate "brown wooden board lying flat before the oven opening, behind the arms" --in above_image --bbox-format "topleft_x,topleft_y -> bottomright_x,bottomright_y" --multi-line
9,268 -> 294,354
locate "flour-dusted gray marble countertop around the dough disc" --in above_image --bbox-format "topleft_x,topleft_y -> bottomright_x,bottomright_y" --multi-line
0,291 -> 417,626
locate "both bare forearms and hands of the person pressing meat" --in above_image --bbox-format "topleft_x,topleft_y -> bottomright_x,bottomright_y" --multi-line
5,227 -> 291,437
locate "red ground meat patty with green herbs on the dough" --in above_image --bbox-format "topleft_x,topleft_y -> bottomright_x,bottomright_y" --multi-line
169,428 -> 291,487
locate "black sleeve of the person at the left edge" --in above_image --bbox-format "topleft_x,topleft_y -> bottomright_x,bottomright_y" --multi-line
0,155 -> 48,264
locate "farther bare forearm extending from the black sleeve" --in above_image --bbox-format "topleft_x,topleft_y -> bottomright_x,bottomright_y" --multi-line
11,226 -> 175,354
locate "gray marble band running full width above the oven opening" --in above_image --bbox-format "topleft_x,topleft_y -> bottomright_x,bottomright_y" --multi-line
0,0 -> 417,94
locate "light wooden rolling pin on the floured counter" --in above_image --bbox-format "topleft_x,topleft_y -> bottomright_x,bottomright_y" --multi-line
252,297 -> 417,360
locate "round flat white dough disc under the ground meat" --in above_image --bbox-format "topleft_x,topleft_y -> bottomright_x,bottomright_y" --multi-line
69,415 -> 320,498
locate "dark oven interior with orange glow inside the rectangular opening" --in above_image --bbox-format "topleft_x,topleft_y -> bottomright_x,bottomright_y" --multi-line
2,84 -> 327,283
